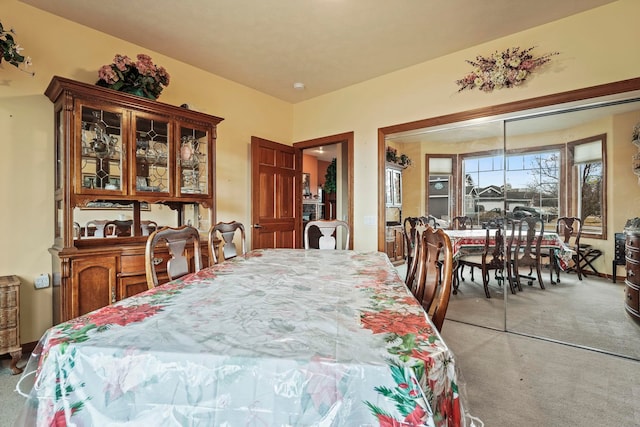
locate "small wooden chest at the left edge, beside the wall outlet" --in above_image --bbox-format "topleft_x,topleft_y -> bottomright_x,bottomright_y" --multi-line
0,276 -> 22,375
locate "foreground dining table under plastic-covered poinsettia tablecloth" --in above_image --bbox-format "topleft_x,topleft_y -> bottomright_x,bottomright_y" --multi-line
16,249 -> 468,427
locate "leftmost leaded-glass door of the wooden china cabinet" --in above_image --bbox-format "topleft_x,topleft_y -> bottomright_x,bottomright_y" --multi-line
76,105 -> 123,193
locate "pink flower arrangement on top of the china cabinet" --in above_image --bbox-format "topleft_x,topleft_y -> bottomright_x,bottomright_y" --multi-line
96,53 -> 170,99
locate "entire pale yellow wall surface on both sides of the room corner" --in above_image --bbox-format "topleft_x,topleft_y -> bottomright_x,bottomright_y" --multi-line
0,0 -> 640,342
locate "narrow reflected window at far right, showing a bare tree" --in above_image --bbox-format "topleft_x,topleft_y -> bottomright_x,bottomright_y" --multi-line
567,134 -> 607,239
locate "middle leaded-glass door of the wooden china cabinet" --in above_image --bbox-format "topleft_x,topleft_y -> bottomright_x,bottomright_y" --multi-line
131,115 -> 174,194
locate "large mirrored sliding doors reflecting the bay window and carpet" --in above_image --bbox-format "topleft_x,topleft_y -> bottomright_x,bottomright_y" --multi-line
379,79 -> 640,360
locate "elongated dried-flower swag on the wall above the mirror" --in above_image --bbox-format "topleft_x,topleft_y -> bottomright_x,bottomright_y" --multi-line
456,46 -> 559,92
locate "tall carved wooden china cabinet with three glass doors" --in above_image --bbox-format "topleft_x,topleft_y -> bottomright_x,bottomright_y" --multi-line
45,77 -> 223,324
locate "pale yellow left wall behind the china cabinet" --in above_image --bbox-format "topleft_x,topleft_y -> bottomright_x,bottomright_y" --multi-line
0,0 -> 293,343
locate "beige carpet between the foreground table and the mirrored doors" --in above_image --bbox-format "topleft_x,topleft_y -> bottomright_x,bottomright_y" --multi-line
442,320 -> 640,427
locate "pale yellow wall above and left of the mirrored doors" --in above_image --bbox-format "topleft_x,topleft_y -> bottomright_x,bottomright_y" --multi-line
293,0 -> 640,249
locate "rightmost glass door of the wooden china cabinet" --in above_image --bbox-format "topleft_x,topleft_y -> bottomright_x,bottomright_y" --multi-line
177,127 -> 211,195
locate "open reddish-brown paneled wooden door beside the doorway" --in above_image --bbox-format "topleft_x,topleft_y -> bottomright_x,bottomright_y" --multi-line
251,136 -> 302,249
